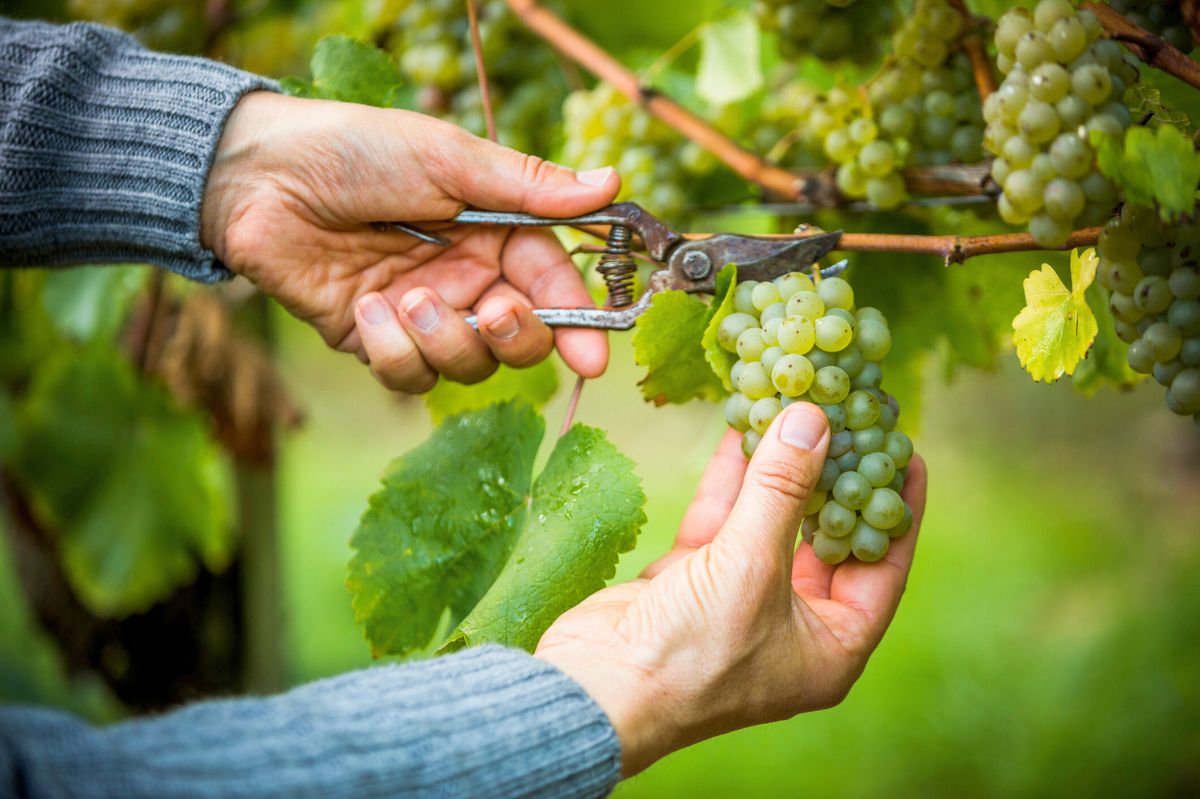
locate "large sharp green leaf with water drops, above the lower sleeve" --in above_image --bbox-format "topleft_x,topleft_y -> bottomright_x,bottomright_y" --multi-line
347,402 -> 644,655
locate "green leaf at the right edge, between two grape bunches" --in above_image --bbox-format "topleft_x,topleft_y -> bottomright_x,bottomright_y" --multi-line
1092,125 -> 1200,218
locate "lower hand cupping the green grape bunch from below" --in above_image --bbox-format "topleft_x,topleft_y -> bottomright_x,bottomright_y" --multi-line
536,403 -> 925,776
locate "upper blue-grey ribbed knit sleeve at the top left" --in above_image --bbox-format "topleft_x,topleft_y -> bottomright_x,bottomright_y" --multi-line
0,18 -> 275,282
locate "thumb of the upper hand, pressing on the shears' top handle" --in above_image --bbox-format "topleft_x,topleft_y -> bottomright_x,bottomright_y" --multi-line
439,127 -> 620,217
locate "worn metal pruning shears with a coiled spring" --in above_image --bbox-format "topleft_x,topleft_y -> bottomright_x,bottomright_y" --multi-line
383,203 -> 846,330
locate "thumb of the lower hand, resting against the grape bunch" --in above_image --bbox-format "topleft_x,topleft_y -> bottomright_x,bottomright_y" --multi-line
721,402 -> 829,563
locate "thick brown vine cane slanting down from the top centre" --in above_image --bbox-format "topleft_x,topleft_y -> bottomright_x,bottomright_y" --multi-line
506,0 -> 997,208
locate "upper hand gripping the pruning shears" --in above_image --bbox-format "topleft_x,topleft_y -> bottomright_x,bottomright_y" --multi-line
200,92 -> 620,392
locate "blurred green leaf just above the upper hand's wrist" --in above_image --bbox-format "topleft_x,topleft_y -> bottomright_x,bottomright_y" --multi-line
280,36 -> 403,108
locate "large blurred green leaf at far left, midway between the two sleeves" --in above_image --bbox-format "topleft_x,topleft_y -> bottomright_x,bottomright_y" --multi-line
13,348 -> 234,617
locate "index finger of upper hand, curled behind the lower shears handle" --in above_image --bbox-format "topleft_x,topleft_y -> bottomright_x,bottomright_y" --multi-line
500,228 -> 608,378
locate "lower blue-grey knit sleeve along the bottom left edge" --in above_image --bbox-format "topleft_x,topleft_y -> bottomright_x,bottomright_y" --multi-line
0,647 -> 620,799
